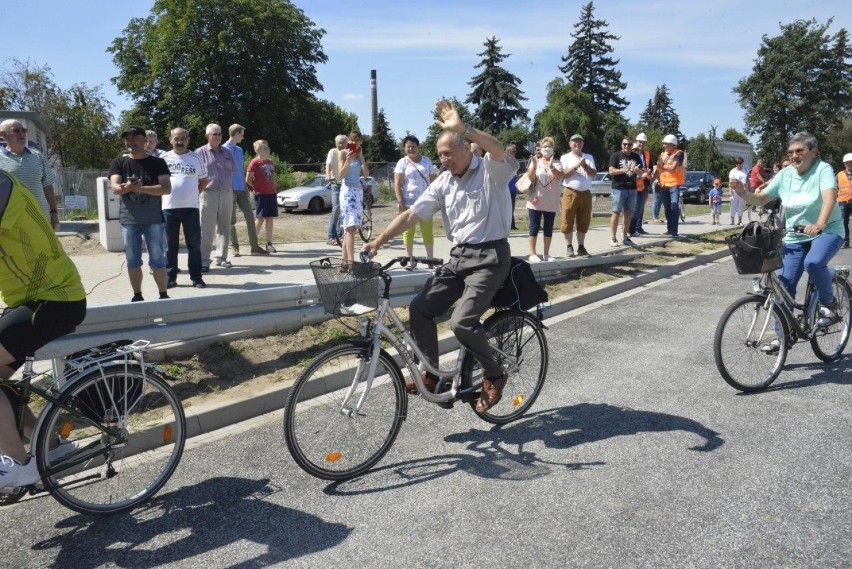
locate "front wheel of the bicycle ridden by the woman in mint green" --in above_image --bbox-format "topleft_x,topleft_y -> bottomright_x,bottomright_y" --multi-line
713,296 -> 789,392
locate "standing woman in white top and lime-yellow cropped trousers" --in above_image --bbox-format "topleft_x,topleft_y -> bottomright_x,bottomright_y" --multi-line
393,134 -> 438,258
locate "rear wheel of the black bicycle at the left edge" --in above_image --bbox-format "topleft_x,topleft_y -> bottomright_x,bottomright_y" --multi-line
35,364 -> 186,515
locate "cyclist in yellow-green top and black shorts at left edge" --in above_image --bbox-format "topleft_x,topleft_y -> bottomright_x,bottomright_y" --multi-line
0,171 -> 86,489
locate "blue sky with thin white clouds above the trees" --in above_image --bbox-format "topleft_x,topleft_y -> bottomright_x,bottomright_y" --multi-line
0,0 -> 852,146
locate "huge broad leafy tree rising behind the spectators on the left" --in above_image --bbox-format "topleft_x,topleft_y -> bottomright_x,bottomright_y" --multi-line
108,0 -> 330,161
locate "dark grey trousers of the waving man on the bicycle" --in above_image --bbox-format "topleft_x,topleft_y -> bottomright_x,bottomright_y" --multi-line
409,239 -> 512,379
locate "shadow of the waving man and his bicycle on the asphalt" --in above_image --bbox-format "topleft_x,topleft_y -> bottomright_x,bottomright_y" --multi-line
325,403 -> 724,495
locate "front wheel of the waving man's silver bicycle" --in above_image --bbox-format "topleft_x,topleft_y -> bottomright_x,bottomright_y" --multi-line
284,346 -> 408,480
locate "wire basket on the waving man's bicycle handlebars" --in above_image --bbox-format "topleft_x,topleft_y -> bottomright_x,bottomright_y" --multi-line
310,257 -> 382,318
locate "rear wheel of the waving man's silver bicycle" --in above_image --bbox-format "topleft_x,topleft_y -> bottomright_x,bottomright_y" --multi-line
461,310 -> 550,425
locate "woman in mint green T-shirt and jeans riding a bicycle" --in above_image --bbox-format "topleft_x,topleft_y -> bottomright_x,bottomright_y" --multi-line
730,132 -> 843,326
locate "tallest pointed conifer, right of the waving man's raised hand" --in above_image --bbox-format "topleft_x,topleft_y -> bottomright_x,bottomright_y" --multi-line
559,2 -> 627,115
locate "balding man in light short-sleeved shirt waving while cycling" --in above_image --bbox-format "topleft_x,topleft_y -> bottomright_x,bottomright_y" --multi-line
363,99 -> 518,413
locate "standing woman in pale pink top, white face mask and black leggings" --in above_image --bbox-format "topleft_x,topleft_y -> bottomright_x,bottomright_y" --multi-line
527,136 -> 562,263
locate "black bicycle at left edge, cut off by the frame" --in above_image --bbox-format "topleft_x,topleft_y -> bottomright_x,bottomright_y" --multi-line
0,340 -> 186,515
